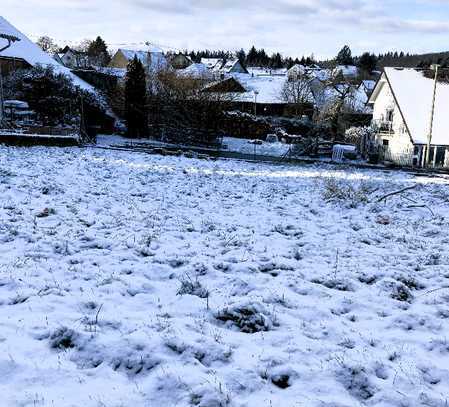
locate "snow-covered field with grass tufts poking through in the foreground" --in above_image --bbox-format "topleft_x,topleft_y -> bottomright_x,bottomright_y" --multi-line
0,147 -> 449,407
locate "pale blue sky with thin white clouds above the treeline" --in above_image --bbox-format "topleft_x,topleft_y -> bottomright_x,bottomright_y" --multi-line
0,0 -> 449,58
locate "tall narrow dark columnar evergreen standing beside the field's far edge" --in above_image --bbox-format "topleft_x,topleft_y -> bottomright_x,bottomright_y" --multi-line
125,56 -> 148,137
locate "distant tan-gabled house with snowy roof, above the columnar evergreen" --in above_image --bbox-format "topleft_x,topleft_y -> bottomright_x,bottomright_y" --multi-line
109,47 -> 168,72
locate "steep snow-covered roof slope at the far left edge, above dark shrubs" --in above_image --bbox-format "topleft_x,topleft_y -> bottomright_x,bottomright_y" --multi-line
0,16 -> 95,92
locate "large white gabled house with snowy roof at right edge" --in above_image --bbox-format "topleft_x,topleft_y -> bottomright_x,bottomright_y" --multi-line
369,68 -> 449,167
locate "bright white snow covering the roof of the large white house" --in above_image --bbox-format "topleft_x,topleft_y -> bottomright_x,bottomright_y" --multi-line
385,68 -> 449,146
